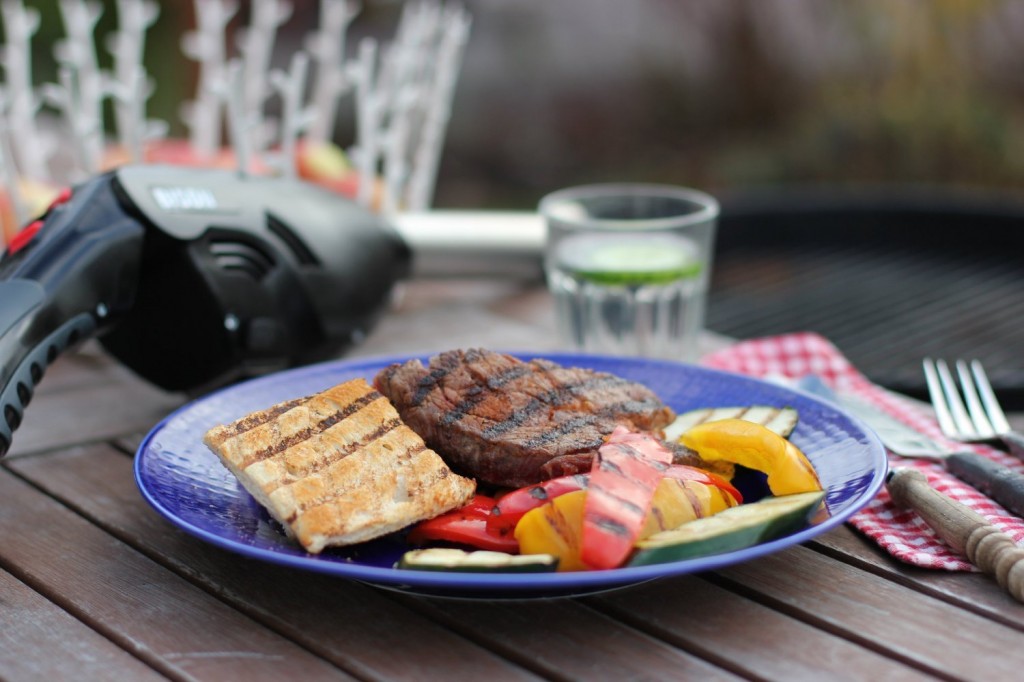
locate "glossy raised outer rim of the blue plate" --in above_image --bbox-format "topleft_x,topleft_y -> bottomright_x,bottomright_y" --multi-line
133,350 -> 888,593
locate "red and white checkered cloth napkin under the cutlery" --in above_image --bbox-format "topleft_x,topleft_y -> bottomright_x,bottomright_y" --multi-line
701,333 -> 1024,570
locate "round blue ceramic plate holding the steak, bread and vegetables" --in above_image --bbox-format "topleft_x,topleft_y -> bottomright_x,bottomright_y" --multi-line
135,354 -> 886,598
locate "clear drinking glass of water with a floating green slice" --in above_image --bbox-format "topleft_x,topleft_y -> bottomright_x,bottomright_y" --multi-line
539,184 -> 719,361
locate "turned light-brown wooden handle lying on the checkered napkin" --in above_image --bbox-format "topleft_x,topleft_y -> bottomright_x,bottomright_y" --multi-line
887,469 -> 1024,602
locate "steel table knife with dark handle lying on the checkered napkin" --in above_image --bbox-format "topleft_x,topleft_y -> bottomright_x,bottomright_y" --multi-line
797,375 -> 1024,518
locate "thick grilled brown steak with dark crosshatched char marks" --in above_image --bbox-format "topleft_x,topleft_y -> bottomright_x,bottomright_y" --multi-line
374,349 -> 675,486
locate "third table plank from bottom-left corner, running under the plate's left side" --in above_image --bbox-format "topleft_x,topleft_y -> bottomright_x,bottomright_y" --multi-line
10,446 -> 534,680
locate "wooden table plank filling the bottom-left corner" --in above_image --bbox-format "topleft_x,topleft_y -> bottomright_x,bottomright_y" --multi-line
0,570 -> 167,682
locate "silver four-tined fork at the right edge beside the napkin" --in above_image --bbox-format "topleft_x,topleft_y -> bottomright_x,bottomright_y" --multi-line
923,358 -> 1024,459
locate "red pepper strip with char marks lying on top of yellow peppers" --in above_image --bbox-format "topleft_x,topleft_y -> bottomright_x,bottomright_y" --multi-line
581,426 -> 672,568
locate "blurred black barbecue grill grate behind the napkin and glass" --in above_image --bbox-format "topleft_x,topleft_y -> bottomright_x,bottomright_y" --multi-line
708,187 -> 1024,403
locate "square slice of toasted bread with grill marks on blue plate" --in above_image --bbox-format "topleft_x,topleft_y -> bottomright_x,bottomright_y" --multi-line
203,379 -> 476,554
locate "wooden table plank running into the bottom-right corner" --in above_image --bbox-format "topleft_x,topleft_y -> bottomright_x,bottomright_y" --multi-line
718,547 -> 1024,680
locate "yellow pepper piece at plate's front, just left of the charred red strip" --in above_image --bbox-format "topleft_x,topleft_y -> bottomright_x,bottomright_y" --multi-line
514,491 -> 588,571
